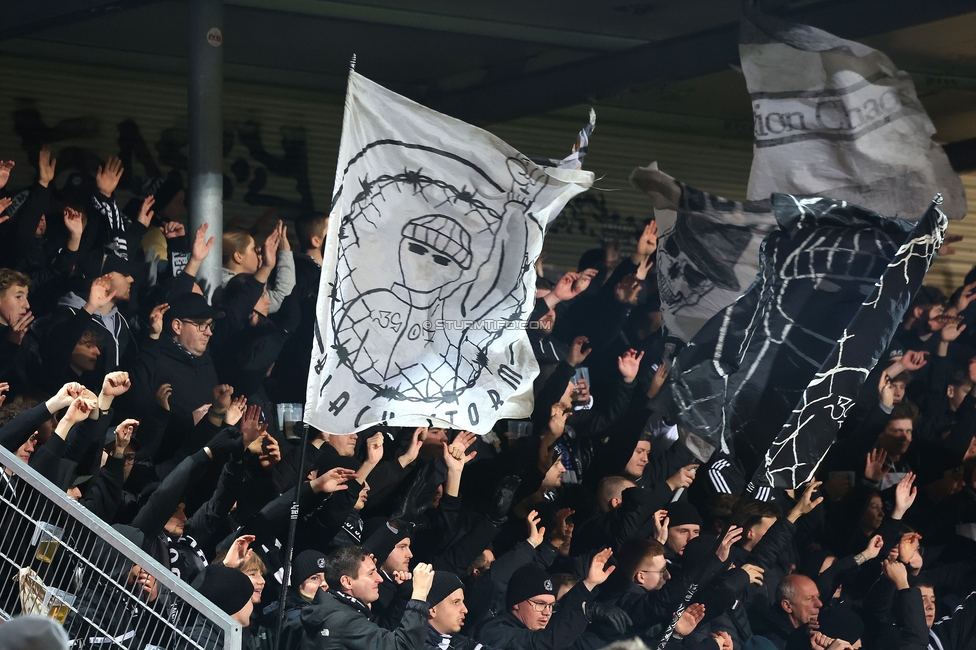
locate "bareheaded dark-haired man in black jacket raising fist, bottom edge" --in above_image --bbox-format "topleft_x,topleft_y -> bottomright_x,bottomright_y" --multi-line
301,546 -> 434,650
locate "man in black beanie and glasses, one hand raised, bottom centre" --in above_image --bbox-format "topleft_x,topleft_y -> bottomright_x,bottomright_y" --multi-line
478,549 -> 614,650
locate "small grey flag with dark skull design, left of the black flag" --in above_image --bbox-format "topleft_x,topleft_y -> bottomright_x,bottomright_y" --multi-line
630,163 -> 776,343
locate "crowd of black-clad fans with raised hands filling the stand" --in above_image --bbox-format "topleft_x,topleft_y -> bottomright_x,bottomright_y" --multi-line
0,149 -> 976,650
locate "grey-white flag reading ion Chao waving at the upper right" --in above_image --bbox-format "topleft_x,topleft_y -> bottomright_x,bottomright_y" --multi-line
739,10 -> 966,221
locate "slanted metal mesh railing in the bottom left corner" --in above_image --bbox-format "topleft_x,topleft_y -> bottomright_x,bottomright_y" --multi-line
0,447 -> 241,650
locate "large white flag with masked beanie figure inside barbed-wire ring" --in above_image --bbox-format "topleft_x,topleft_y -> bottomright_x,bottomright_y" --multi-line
308,72 -> 593,433
